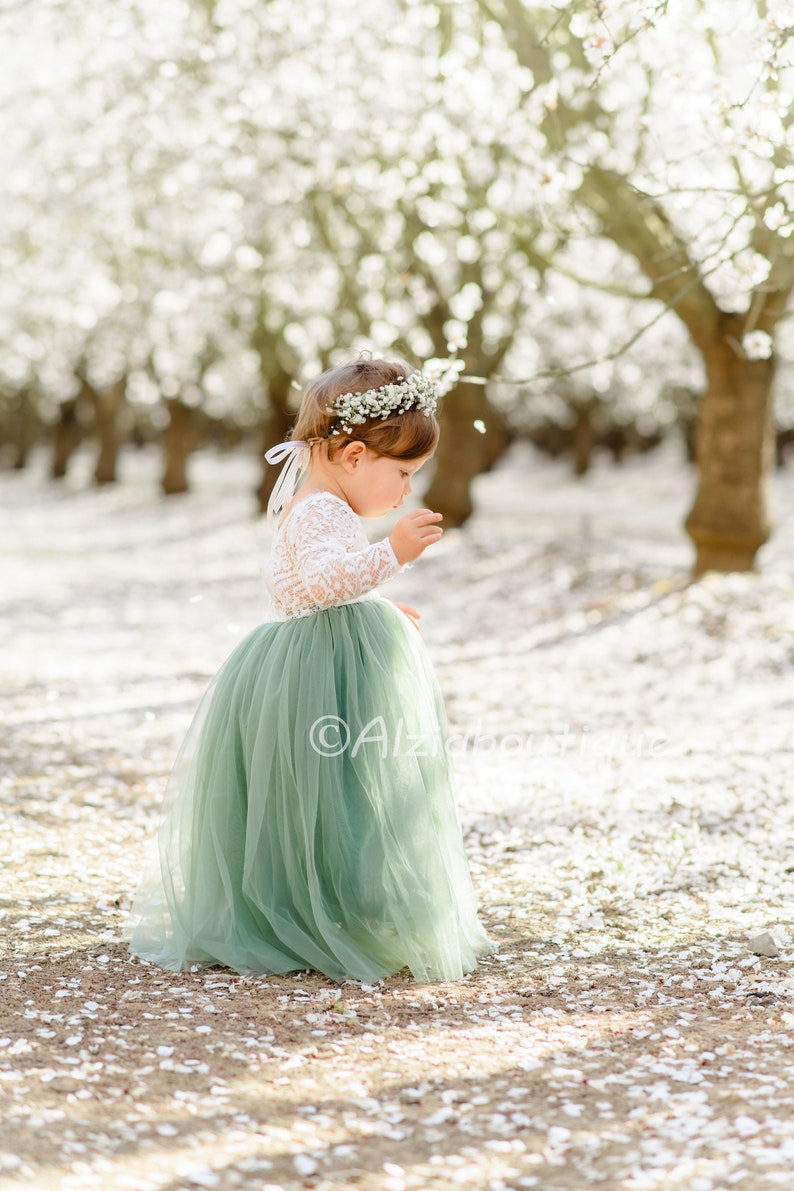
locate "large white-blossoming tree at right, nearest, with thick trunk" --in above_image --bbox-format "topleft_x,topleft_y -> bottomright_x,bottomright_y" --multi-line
454,0 -> 794,570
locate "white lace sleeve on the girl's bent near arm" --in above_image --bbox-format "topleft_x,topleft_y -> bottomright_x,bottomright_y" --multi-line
285,499 -> 400,607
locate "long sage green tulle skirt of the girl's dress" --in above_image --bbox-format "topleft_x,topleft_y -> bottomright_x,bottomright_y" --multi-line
127,598 -> 490,981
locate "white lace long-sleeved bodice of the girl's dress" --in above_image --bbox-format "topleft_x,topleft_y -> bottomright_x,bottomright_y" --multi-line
267,492 -> 400,618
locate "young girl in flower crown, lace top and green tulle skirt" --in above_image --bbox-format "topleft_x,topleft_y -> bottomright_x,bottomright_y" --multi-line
125,360 -> 490,981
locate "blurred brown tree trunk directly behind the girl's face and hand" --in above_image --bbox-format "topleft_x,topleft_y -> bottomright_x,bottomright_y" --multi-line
424,382 -> 509,529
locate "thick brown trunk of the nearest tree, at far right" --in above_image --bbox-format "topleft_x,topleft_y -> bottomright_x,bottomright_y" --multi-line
686,314 -> 774,575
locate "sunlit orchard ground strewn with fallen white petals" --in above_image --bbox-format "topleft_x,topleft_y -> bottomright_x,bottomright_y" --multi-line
0,447 -> 794,1191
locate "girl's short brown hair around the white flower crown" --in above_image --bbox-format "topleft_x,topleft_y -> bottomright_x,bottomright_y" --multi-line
292,360 -> 438,459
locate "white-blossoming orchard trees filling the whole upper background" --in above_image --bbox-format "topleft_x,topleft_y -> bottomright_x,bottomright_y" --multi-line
0,0 -> 794,569
